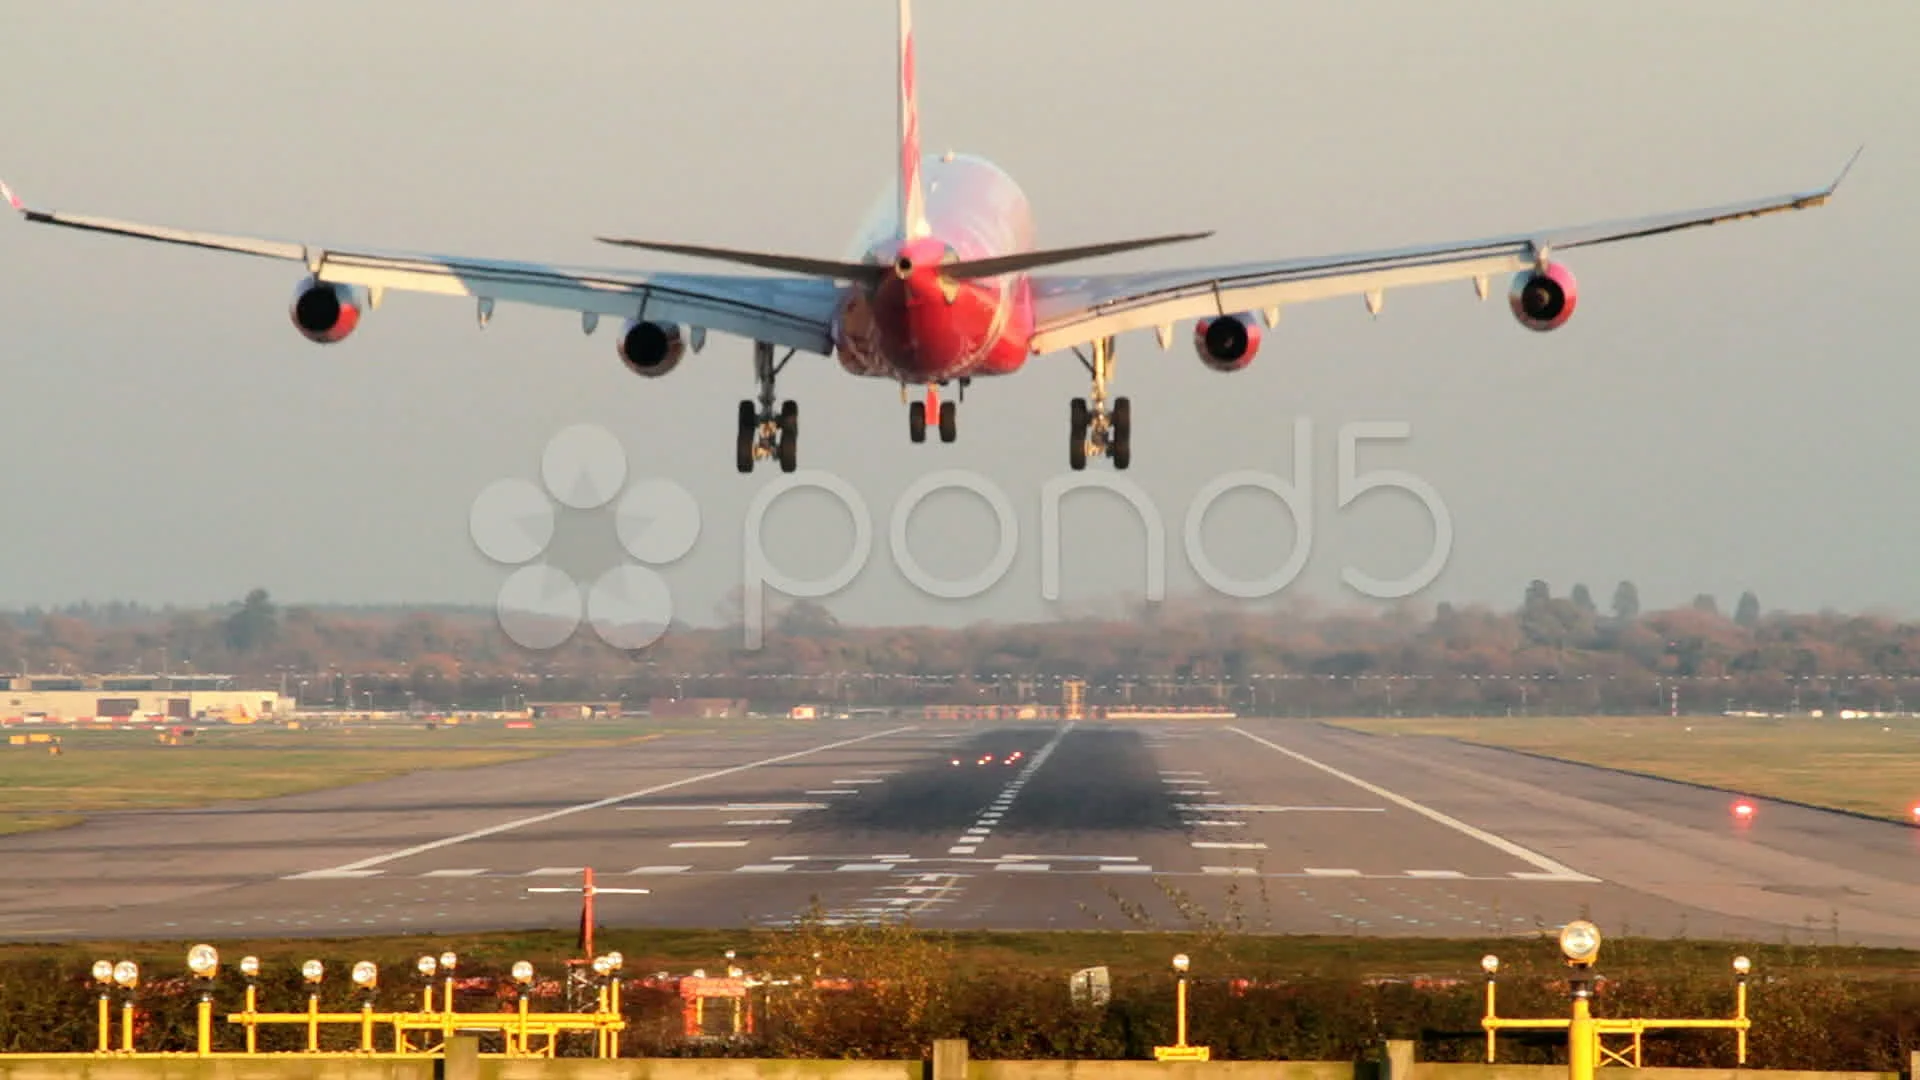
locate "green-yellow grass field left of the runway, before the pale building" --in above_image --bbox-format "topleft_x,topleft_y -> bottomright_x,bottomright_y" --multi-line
0,719 -> 714,834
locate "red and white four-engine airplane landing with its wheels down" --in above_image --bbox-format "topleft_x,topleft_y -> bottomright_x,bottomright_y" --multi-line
0,0 -> 1864,473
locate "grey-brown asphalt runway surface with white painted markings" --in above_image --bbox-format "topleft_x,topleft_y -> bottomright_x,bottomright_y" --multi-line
0,721 -> 1920,947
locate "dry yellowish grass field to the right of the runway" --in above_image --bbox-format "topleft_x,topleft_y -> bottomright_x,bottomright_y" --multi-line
1331,717 -> 1920,822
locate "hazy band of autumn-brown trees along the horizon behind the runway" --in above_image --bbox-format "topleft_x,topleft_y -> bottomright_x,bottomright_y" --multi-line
0,580 -> 1920,715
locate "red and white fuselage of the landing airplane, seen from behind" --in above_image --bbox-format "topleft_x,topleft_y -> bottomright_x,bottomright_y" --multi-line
833,154 -> 1033,382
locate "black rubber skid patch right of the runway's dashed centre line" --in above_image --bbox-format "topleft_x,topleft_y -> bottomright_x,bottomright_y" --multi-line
995,724 -> 1187,836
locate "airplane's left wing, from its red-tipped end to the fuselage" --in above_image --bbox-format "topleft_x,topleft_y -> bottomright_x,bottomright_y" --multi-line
0,184 -> 839,356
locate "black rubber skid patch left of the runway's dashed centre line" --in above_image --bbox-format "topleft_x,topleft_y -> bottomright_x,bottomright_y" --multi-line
795,726 -> 1071,832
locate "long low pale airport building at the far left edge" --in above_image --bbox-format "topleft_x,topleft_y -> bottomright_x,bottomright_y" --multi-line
0,675 -> 294,726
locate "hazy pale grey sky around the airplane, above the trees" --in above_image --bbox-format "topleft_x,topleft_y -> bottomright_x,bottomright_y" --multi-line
0,0 -> 1920,623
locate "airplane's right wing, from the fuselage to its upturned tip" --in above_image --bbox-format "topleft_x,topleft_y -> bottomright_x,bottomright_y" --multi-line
1031,150 -> 1860,354
